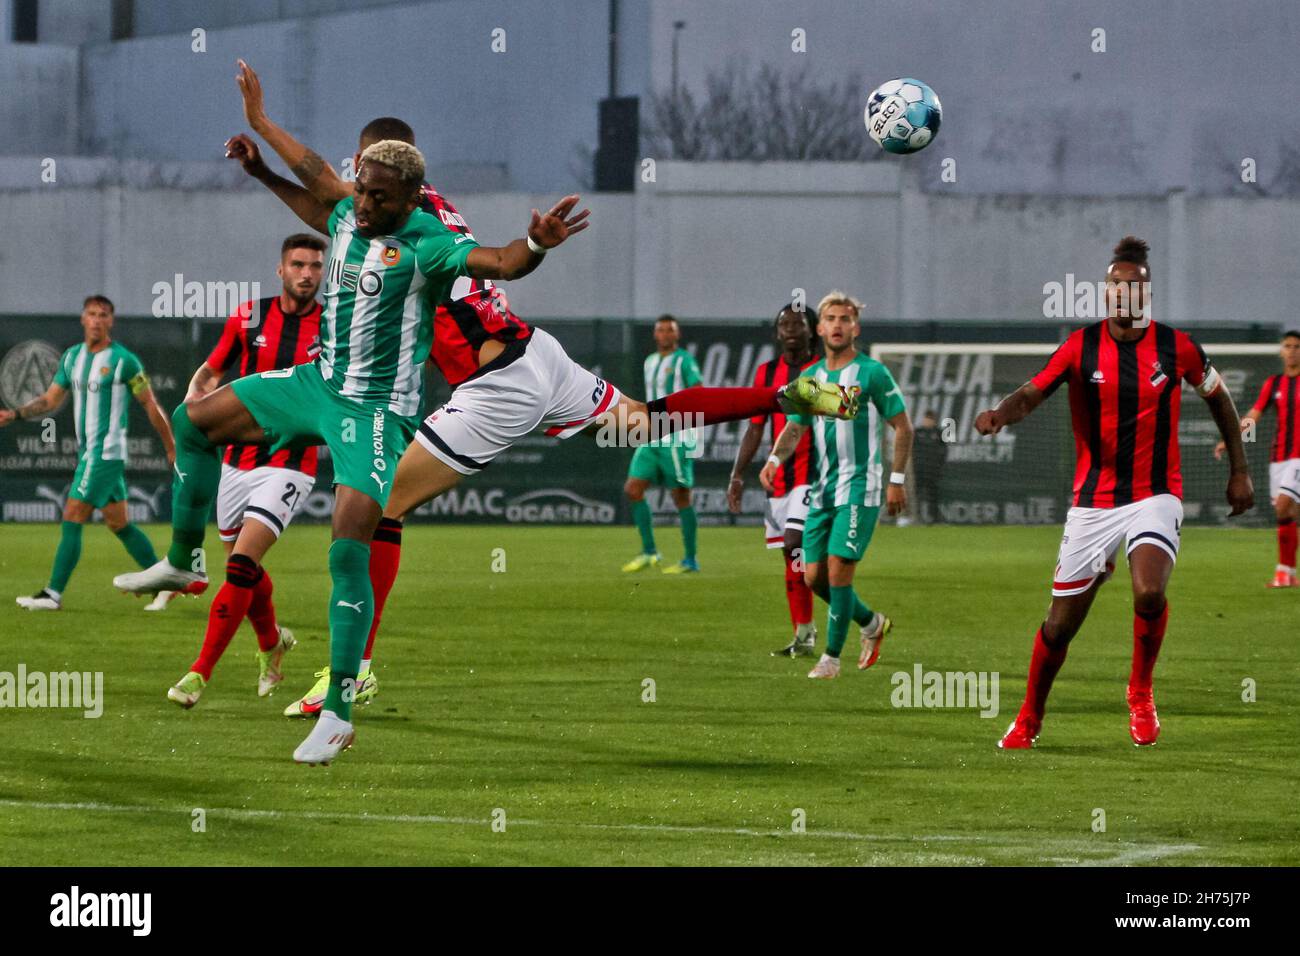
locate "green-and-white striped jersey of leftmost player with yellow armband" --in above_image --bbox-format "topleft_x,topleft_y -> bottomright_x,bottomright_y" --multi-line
55,342 -> 150,462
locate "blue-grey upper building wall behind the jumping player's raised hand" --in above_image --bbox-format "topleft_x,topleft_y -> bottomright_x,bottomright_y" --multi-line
81,0 -> 607,191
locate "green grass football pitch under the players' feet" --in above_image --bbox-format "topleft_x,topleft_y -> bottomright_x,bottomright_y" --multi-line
0,525 -> 1300,865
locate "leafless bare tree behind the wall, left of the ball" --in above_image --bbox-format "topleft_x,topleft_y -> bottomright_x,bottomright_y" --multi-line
642,61 -> 884,161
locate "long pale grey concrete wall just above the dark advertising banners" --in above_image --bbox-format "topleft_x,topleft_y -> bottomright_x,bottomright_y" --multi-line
0,157 -> 1300,325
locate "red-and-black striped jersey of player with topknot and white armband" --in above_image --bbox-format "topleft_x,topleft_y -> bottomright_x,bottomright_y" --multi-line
1032,320 -> 1218,507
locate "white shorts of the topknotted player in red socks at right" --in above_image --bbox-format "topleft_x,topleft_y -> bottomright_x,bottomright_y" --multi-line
1052,494 -> 1183,597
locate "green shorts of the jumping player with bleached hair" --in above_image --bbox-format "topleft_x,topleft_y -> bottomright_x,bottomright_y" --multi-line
230,364 -> 419,507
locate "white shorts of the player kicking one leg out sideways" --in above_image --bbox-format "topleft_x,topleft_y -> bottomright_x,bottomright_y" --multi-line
416,329 -> 621,475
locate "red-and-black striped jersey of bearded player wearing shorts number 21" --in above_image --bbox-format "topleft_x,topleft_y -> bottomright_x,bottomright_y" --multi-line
207,295 -> 321,475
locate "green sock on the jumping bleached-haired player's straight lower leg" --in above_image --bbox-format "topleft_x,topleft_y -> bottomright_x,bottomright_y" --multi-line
322,537 -> 374,721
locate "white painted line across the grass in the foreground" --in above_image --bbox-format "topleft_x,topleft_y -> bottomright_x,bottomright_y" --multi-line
0,800 -> 1203,866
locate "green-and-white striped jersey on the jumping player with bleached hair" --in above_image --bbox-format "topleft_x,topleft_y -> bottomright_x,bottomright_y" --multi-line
317,196 -> 478,416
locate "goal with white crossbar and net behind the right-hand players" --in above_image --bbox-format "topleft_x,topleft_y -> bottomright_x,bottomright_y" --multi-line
871,343 -> 1279,524
